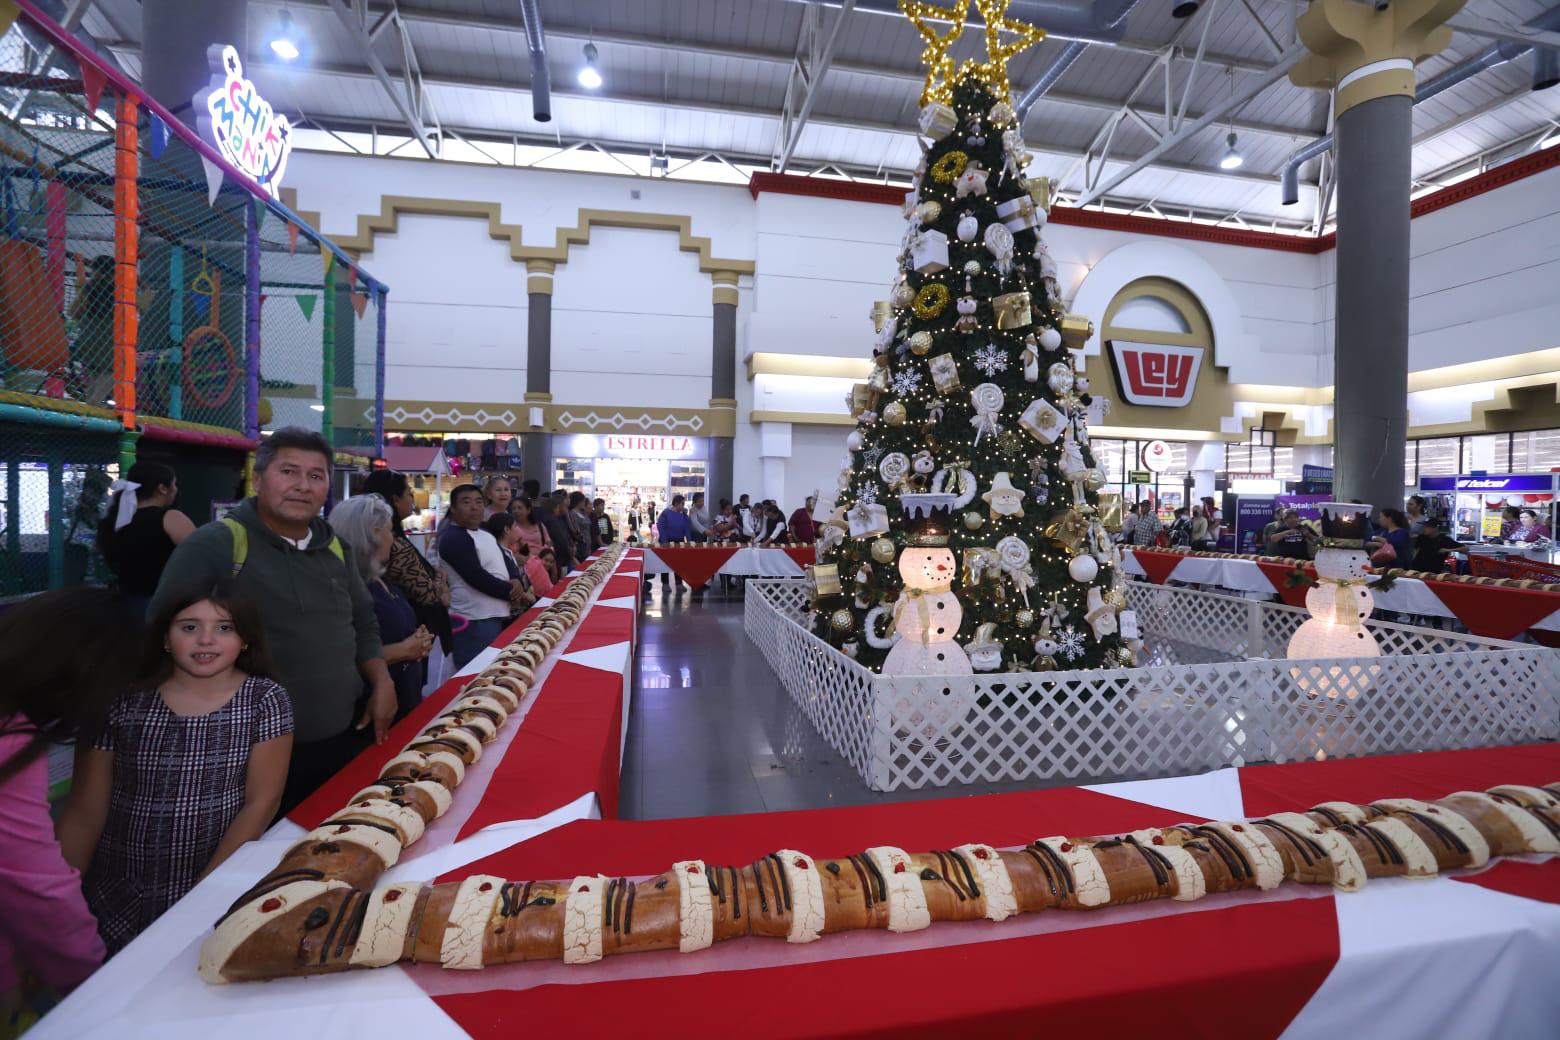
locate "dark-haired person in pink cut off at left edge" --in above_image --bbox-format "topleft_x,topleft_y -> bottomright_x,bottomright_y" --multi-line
0,588 -> 140,1023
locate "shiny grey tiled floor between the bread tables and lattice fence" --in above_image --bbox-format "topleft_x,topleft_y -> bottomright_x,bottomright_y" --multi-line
619,582 -> 1044,820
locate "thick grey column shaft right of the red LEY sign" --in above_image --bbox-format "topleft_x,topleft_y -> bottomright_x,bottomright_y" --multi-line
1332,94 -> 1413,508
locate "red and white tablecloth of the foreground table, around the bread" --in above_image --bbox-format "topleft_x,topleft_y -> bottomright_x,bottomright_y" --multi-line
34,735 -> 1560,1040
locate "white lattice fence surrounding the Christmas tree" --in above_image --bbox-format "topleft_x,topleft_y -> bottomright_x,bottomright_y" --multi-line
746,580 -> 1560,791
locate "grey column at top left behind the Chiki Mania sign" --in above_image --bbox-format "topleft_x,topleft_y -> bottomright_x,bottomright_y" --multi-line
140,0 -> 246,116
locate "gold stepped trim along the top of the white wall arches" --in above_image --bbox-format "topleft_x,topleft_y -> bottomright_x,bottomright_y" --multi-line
308,195 -> 755,274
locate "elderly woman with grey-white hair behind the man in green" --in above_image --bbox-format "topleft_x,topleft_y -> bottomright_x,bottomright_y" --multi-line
331,494 -> 434,722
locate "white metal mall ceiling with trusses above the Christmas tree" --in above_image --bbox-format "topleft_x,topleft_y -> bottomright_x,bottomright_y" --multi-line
54,0 -> 1560,234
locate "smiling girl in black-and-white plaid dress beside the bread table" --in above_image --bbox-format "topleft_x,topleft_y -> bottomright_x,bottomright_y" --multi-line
62,580 -> 292,953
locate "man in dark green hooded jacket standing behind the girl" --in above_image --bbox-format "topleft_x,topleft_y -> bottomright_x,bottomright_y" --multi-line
150,427 -> 396,814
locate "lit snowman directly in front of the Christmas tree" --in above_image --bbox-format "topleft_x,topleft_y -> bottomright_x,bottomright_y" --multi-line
869,494 -> 973,675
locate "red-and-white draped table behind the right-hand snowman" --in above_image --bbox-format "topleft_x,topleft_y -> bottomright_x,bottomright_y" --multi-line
1122,549 -> 1560,646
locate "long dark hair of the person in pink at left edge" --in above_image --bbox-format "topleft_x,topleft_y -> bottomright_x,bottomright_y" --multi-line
0,586 -> 140,786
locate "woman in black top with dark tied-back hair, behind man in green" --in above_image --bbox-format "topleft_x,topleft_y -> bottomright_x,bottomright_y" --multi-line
98,458 -> 195,617
